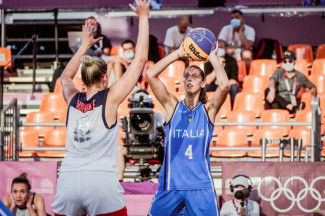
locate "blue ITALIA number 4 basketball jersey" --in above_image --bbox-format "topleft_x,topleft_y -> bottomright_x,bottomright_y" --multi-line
159,100 -> 214,190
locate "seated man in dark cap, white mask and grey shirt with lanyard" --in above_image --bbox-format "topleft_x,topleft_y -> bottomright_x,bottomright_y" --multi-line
265,50 -> 317,113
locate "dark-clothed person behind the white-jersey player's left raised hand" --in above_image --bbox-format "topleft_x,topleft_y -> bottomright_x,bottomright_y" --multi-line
75,16 -> 112,58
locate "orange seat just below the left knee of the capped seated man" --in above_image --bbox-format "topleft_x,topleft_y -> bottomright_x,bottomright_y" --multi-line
260,109 -> 291,136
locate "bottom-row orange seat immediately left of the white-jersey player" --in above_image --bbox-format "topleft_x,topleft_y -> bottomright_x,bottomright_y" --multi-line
36,127 -> 67,158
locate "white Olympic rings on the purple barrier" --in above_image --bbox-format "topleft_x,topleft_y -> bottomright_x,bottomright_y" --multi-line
257,176 -> 325,213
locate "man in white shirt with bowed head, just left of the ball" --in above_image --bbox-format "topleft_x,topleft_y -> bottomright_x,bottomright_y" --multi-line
164,16 -> 192,54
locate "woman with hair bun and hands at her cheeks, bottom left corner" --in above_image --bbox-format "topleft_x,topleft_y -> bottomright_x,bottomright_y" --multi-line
3,173 -> 46,216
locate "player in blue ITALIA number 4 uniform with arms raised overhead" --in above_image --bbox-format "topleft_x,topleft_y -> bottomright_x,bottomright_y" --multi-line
147,42 -> 229,216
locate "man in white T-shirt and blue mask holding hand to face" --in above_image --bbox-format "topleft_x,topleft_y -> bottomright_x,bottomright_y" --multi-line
218,9 -> 255,71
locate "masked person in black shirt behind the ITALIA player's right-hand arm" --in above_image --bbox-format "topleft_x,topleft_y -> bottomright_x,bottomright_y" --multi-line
204,40 -> 239,105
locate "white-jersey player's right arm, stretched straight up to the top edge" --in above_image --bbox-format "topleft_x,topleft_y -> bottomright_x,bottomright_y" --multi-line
107,0 -> 151,105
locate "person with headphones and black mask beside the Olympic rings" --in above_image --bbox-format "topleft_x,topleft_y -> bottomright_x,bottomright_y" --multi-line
220,175 -> 260,216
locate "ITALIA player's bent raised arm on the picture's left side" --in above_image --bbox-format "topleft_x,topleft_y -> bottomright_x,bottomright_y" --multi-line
147,45 -> 186,121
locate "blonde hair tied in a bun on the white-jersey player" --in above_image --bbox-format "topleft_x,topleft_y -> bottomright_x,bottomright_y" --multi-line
81,55 -> 107,87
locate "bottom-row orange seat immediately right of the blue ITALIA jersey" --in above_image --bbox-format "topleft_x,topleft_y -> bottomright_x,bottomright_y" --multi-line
210,129 -> 248,157
